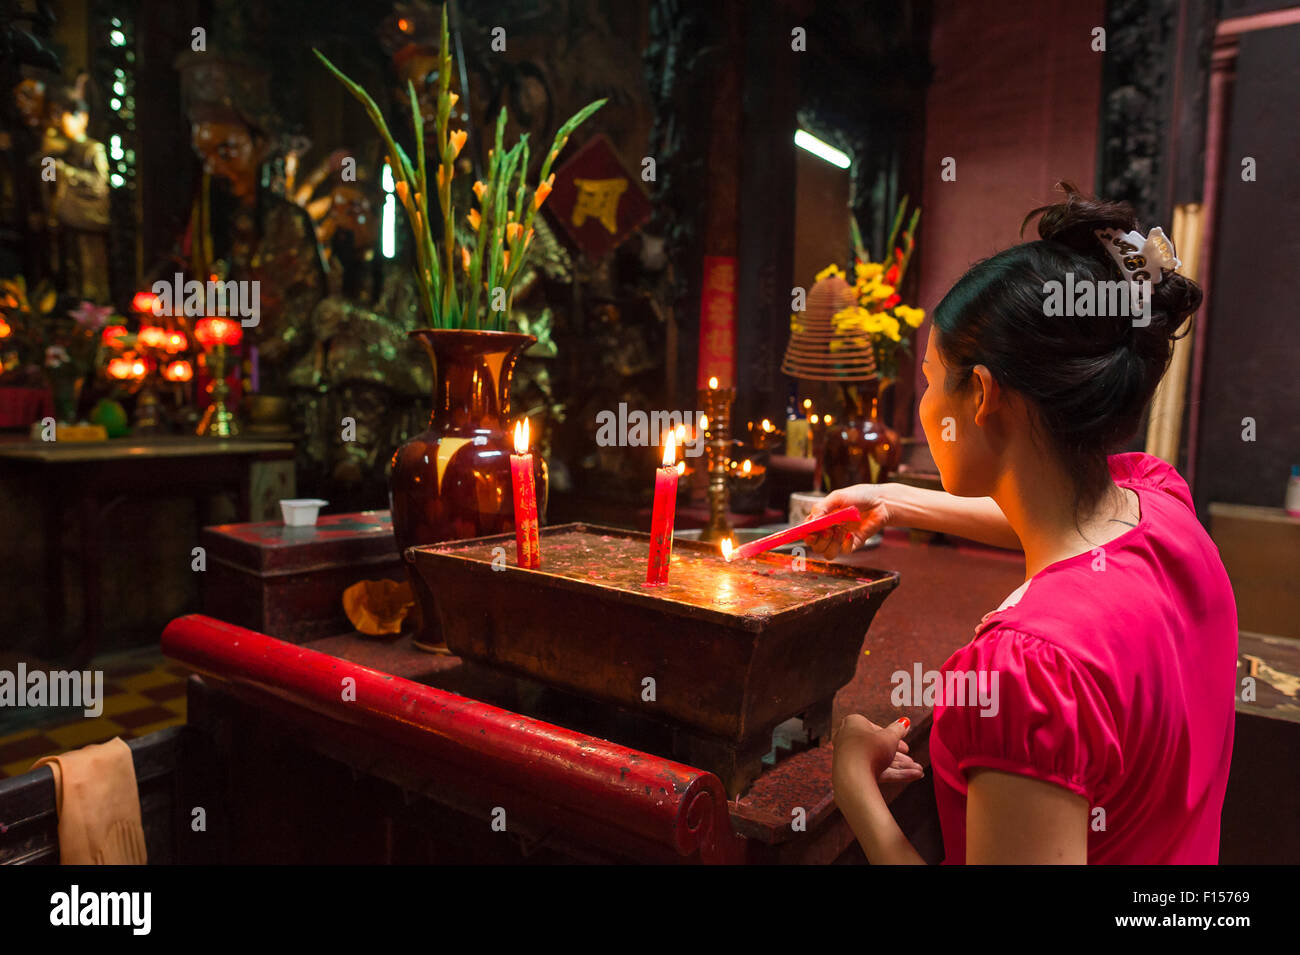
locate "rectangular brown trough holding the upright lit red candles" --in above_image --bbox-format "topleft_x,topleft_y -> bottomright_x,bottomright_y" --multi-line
408,524 -> 898,795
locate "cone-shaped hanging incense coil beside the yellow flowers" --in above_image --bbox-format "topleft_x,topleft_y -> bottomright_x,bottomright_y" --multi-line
781,275 -> 878,382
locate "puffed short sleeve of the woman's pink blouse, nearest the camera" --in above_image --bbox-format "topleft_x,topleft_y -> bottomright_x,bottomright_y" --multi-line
933,628 -> 1123,806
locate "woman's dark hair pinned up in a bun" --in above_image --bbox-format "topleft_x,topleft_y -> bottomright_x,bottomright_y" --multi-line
933,182 -> 1201,509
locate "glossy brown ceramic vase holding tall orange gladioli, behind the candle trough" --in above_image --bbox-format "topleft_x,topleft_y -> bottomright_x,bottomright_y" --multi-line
389,329 -> 546,650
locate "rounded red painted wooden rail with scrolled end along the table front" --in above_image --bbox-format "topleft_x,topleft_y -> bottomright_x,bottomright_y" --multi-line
163,615 -> 745,863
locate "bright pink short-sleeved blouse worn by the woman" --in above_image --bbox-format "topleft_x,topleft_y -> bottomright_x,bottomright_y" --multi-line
930,453 -> 1238,864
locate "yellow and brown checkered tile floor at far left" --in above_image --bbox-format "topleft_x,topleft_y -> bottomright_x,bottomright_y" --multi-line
0,652 -> 189,777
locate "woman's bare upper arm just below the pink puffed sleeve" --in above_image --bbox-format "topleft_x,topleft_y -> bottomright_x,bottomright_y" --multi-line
972,769 -> 1088,865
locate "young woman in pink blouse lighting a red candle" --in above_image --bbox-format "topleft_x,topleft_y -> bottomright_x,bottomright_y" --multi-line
813,185 -> 1238,864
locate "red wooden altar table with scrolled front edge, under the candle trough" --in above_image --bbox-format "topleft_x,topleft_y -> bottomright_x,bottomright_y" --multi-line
164,531 -> 1023,863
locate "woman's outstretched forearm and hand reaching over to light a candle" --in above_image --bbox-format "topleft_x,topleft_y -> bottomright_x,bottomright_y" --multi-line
809,483 -> 1022,560
